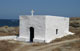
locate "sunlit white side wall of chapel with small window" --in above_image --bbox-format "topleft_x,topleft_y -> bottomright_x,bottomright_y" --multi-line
45,16 -> 69,42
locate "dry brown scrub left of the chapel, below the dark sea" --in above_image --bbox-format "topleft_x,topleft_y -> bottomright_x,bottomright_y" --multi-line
0,26 -> 19,36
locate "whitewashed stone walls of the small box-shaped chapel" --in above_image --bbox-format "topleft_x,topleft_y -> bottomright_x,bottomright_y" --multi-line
18,15 -> 69,43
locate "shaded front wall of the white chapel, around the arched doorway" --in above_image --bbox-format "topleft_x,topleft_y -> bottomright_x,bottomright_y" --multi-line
18,16 -> 45,41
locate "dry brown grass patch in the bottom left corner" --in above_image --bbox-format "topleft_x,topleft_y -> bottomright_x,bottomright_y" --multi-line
0,40 -> 19,51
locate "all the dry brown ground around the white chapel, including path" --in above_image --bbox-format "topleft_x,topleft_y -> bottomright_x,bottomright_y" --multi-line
0,17 -> 80,51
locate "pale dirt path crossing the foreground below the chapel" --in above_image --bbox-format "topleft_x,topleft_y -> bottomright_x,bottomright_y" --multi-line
13,38 -> 80,51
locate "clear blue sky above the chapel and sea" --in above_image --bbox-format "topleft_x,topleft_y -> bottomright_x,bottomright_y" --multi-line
0,0 -> 80,19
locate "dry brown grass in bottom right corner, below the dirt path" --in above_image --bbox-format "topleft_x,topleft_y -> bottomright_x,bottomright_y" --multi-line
52,41 -> 80,51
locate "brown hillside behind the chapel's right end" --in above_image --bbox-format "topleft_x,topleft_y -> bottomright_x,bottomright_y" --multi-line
70,17 -> 80,34
